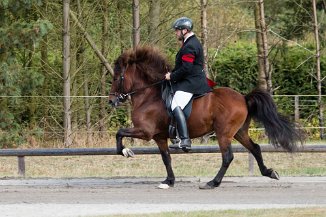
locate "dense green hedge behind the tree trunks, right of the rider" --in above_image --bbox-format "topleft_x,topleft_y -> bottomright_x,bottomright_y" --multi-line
211,42 -> 326,118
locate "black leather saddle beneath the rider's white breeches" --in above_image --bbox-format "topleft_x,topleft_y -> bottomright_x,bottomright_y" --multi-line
161,81 -> 207,139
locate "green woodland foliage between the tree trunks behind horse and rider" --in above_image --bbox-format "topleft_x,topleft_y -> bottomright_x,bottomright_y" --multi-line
0,0 -> 326,148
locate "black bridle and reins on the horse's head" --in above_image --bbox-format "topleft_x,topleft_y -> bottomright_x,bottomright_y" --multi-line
109,64 -> 165,105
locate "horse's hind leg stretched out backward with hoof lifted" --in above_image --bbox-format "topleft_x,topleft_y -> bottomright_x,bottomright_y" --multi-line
234,129 -> 279,179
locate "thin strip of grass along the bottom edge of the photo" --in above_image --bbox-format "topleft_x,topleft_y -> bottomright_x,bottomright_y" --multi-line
88,208 -> 326,217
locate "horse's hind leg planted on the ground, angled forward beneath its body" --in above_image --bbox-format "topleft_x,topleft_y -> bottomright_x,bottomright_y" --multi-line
199,144 -> 233,189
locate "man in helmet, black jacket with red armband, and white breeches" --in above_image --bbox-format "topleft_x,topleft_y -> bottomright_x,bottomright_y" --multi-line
165,17 -> 211,150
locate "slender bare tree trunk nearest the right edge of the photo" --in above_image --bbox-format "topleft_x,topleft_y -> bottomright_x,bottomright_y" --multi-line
312,0 -> 325,139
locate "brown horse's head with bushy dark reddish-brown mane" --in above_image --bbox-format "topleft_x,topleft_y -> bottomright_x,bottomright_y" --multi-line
109,46 -> 169,106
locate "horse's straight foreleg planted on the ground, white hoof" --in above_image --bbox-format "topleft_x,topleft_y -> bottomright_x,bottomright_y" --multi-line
155,139 -> 175,189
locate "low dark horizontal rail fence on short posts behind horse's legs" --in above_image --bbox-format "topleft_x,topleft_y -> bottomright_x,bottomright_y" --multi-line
0,145 -> 326,176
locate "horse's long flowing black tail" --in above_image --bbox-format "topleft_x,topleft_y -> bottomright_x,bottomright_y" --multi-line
245,89 -> 304,151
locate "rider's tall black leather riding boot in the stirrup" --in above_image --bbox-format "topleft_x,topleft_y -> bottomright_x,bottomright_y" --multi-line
169,106 -> 191,150
